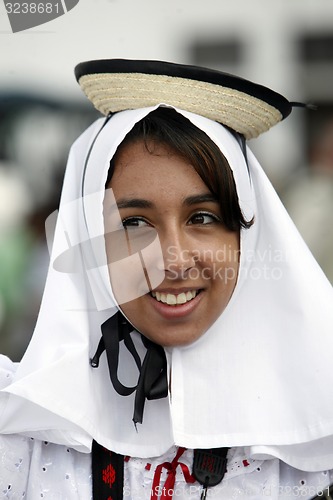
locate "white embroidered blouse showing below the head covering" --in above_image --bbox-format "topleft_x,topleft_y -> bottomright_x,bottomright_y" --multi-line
0,365 -> 333,500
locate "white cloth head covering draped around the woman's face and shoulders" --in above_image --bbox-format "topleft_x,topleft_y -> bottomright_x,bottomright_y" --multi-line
0,106 -> 333,471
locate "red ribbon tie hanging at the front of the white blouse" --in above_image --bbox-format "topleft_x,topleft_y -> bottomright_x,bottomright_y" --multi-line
150,448 -> 195,500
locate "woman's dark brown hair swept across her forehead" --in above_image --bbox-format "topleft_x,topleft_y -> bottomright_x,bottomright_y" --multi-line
106,107 -> 253,231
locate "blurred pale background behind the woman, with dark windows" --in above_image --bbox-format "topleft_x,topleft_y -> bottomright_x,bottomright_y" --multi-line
0,0 -> 333,361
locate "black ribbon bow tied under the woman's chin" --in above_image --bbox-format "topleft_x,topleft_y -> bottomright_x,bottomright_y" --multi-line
90,311 -> 168,425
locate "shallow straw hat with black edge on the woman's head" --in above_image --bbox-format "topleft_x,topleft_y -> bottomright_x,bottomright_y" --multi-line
75,59 -> 292,139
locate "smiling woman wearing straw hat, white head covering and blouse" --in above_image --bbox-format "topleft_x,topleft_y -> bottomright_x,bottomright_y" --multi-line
0,60 -> 333,500
